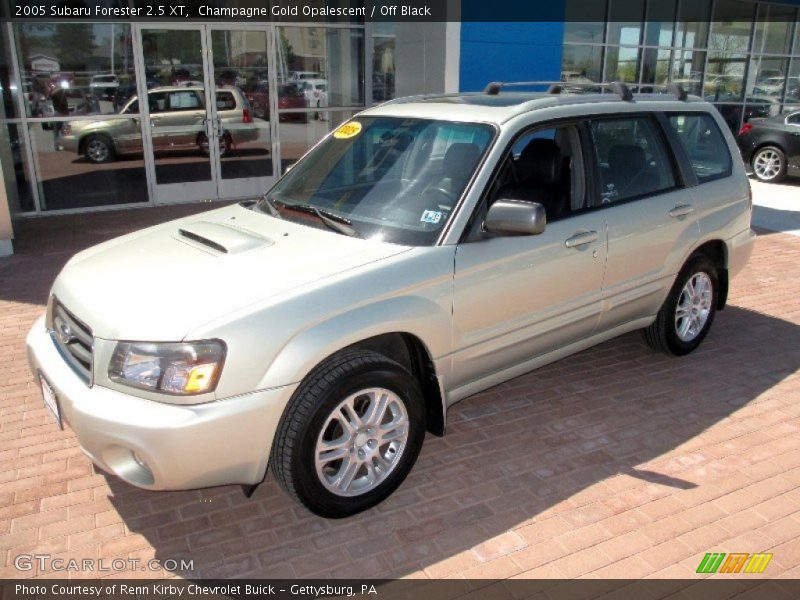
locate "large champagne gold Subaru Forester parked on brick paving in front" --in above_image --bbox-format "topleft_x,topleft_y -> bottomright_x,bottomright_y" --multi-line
27,86 -> 755,517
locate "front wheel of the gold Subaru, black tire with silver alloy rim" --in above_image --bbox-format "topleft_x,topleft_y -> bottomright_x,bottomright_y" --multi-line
270,350 -> 425,518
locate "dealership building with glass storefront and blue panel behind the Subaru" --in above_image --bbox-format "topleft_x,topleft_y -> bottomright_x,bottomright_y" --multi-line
0,0 -> 800,256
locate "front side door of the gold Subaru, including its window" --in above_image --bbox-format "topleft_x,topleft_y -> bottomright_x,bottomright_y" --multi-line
450,124 -> 607,388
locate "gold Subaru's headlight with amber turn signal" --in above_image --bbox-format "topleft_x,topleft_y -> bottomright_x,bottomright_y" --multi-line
108,340 -> 225,395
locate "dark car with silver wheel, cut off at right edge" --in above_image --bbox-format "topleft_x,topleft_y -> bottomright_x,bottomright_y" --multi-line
736,111 -> 800,182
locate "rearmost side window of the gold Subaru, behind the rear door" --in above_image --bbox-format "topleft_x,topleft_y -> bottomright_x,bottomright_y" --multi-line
669,113 -> 732,183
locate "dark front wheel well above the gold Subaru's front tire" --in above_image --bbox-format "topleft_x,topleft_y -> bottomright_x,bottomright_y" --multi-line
346,332 -> 445,437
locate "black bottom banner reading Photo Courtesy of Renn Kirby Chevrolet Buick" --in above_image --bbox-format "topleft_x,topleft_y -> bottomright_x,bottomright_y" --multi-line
0,575 -> 800,600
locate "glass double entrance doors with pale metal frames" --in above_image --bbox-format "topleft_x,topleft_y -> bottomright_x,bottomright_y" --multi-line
137,24 -> 275,204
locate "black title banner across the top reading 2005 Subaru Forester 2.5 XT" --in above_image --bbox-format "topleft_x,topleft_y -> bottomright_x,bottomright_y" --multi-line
6,0 -> 797,24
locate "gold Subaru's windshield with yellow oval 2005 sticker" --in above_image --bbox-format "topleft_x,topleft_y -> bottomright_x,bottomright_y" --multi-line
260,117 -> 494,246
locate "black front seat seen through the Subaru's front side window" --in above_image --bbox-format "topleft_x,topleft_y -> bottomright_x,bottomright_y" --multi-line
497,138 -> 569,221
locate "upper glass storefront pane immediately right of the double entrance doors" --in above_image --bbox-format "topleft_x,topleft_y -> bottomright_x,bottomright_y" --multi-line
275,27 -> 364,108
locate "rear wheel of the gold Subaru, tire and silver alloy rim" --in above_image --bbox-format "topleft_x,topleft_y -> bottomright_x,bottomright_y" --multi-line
643,254 -> 719,356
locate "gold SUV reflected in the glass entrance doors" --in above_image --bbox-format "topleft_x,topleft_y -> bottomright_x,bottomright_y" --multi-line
59,86 -> 258,163
